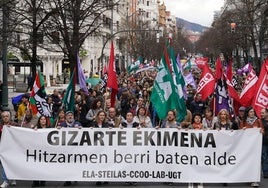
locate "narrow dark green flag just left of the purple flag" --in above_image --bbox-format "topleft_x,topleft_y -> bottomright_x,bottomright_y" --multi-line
62,70 -> 76,112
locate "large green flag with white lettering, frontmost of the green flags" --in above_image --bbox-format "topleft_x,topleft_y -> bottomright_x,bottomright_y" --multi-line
150,47 -> 178,120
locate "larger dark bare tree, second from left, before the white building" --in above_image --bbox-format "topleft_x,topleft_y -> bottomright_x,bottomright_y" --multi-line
44,0 -> 118,75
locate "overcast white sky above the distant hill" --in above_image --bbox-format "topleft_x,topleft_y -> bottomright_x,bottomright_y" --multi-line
162,0 -> 224,26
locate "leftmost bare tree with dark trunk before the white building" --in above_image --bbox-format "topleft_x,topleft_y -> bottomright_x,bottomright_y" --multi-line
10,0 -> 54,82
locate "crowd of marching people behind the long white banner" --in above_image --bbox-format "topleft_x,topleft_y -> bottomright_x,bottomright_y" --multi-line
0,68 -> 268,188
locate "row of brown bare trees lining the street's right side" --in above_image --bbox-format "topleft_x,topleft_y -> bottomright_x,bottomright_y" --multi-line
196,0 -> 268,73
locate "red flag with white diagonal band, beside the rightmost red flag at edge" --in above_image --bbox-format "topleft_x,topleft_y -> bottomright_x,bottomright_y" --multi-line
240,69 -> 258,106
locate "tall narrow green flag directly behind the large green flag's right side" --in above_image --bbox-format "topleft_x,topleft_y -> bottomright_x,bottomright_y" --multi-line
168,46 -> 187,122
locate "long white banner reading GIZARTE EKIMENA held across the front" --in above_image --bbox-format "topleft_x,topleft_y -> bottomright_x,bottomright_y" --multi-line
0,126 -> 262,183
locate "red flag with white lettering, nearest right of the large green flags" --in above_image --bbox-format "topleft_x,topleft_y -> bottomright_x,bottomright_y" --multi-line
196,64 -> 215,101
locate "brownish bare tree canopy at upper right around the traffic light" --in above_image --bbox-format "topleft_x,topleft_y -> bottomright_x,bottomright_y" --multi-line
196,0 -> 267,69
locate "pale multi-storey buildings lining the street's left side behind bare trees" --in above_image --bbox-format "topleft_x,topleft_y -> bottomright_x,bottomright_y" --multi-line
0,0 -> 176,85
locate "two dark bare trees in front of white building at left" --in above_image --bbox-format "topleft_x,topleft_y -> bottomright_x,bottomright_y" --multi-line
1,0 -> 119,78
